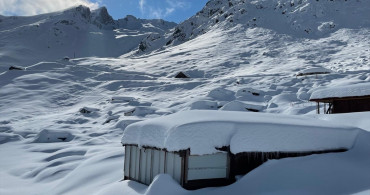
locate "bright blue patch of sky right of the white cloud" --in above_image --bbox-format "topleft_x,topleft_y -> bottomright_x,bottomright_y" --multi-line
96,0 -> 207,23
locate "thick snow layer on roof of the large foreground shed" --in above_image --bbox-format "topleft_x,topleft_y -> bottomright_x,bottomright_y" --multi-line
122,110 -> 358,155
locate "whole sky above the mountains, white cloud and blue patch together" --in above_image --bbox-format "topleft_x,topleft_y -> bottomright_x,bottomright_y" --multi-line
0,0 -> 208,23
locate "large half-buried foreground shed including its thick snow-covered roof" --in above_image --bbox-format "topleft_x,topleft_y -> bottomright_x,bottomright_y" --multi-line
122,110 -> 358,189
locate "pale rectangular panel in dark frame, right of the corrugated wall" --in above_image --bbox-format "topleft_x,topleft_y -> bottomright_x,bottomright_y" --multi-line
187,153 -> 228,180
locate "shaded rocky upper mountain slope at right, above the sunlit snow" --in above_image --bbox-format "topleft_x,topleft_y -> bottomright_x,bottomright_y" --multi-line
139,0 -> 370,52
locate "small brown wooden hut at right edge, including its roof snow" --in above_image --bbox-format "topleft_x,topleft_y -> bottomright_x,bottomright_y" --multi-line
310,83 -> 370,114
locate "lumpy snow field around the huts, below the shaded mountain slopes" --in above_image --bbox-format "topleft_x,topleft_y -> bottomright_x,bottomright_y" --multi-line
0,0 -> 370,195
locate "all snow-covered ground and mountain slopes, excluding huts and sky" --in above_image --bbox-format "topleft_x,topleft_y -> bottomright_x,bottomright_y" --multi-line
0,0 -> 370,195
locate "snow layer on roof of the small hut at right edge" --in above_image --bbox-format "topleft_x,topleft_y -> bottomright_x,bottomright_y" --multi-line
310,83 -> 370,99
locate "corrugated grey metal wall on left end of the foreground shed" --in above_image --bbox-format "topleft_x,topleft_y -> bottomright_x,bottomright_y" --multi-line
124,146 -> 182,185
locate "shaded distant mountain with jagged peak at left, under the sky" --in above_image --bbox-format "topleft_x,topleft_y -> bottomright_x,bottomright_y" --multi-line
0,6 -> 176,66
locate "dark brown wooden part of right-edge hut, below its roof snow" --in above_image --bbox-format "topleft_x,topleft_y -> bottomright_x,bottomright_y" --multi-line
310,95 -> 370,114
